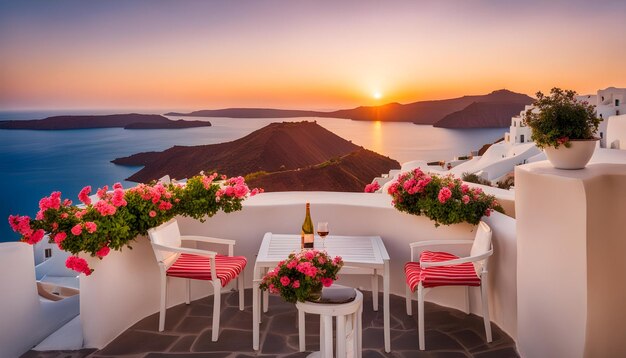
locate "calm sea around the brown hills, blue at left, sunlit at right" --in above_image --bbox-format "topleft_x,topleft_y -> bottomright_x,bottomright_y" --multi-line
0,111 -> 504,241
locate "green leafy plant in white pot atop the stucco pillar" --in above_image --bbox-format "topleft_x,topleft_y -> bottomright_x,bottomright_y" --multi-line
525,88 -> 601,169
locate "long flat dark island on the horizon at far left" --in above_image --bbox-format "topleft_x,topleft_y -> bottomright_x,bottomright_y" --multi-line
0,113 -> 211,130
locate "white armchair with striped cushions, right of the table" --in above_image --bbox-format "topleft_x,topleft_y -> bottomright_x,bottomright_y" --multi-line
404,221 -> 493,350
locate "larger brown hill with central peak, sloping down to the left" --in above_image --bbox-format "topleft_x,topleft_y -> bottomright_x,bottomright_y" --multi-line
113,122 -> 360,182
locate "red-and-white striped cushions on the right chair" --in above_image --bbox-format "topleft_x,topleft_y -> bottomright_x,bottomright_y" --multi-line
404,251 -> 480,291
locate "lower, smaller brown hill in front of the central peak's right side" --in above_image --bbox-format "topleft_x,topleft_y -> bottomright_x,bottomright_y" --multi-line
247,148 -> 400,192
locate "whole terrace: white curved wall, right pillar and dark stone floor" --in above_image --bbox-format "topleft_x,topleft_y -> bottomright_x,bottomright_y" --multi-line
3,162 -> 626,357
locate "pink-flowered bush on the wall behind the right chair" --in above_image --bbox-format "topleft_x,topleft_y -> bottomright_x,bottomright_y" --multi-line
388,168 -> 504,226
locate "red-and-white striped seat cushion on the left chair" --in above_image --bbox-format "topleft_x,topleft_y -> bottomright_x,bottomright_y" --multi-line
167,254 -> 248,287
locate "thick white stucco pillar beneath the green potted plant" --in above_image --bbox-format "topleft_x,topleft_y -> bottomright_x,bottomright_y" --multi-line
515,161 -> 626,357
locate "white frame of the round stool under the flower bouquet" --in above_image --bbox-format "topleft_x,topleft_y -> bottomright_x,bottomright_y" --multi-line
296,289 -> 363,358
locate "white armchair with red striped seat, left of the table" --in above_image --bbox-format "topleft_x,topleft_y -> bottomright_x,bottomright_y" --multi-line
148,219 -> 247,342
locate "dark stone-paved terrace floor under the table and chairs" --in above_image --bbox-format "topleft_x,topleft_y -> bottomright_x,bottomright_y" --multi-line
22,289 -> 518,358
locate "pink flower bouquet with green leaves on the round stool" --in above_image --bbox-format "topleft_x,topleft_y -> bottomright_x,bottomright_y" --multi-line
259,250 -> 343,303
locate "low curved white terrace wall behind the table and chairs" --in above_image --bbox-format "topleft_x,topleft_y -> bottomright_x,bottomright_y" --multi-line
81,192 -> 517,348
